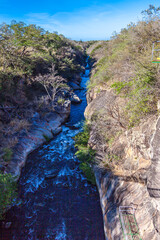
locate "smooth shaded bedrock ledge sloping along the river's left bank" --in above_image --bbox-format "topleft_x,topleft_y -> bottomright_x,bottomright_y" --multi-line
7,100 -> 71,179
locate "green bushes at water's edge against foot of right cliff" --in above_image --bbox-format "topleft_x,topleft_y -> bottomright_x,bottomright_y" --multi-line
75,124 -> 96,185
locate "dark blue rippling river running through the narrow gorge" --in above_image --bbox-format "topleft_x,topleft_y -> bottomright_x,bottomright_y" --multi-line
1,59 -> 105,240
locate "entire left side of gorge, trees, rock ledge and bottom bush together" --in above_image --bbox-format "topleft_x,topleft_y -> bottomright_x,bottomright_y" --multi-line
0,21 -> 87,220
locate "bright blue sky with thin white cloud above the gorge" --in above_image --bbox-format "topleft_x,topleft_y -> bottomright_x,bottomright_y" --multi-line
0,0 -> 160,41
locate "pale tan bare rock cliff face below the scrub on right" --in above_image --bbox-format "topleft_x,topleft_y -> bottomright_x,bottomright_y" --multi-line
85,88 -> 160,240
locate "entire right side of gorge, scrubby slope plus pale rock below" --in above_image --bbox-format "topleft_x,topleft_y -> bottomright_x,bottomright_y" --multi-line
85,6 -> 160,240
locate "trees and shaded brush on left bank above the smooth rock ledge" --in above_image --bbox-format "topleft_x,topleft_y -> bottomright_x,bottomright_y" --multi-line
0,21 -> 86,172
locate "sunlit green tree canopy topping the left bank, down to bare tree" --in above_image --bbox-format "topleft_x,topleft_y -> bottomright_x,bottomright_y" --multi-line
0,21 -> 84,107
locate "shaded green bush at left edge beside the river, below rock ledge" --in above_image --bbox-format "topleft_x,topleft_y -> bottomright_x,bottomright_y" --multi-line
0,173 -> 17,219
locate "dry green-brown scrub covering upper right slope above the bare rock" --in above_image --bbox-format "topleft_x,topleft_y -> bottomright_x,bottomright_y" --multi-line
88,5 -> 160,127
